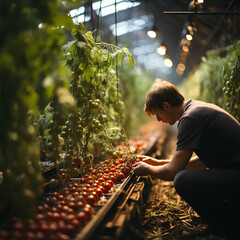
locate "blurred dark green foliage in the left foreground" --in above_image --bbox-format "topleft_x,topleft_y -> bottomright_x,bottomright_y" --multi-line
0,0 -> 83,219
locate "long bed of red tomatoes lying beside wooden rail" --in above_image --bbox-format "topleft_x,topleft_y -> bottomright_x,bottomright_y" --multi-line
0,156 -> 140,240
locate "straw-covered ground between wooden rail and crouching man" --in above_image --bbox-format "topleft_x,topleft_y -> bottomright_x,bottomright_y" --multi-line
139,179 -> 224,240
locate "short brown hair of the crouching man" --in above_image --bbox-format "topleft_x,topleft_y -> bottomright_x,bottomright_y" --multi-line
144,79 -> 184,117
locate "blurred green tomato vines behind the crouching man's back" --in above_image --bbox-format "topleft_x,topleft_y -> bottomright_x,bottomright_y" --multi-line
179,41 -> 240,121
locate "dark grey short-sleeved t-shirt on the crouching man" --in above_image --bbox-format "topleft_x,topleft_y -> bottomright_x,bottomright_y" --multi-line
177,100 -> 240,169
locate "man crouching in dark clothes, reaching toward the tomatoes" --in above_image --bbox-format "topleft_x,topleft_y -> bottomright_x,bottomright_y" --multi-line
133,81 -> 240,236
